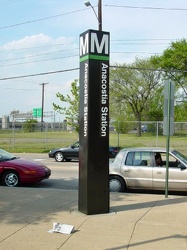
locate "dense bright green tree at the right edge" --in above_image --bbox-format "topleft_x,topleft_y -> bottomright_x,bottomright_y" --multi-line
151,39 -> 187,121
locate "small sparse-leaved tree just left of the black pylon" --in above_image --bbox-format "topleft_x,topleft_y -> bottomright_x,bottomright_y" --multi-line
53,79 -> 79,132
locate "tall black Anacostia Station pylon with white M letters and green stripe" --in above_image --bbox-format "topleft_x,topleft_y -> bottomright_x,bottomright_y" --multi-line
78,30 -> 110,214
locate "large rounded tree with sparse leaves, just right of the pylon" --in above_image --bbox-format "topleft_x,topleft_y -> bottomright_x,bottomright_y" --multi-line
110,58 -> 163,136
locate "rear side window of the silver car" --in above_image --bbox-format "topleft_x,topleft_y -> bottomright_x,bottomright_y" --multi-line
125,151 -> 151,166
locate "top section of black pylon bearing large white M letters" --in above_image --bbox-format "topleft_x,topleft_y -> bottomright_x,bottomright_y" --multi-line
80,30 -> 109,61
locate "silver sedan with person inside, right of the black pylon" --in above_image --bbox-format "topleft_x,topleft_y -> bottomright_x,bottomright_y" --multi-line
109,148 -> 187,192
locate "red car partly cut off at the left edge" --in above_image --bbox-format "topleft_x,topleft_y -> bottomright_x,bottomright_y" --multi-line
0,149 -> 51,187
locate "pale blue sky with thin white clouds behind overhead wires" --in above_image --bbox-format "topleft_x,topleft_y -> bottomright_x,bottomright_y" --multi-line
0,0 -> 187,121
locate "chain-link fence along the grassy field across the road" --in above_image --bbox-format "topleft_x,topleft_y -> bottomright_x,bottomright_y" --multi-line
0,121 -> 187,153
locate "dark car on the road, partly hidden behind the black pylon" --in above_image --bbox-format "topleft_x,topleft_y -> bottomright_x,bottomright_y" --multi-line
49,142 -> 119,162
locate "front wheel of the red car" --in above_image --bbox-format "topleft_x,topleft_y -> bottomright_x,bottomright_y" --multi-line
2,171 -> 20,187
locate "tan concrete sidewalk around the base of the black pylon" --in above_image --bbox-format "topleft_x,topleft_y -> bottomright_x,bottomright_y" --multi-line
0,186 -> 187,250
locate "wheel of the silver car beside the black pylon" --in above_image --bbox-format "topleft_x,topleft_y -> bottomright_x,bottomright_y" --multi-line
109,175 -> 126,192
